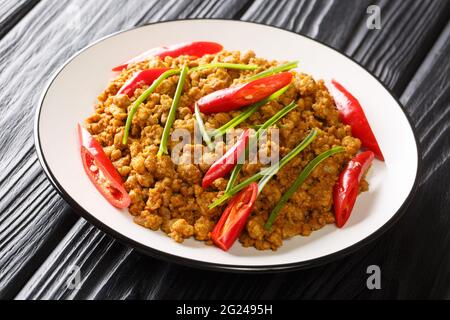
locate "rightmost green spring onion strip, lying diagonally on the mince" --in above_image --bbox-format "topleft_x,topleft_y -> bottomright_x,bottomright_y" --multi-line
264,147 -> 345,230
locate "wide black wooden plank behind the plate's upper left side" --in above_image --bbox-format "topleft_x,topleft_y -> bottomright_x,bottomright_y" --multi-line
0,0 -> 250,298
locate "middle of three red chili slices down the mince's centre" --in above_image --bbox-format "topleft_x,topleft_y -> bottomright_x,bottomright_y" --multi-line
202,130 -> 249,189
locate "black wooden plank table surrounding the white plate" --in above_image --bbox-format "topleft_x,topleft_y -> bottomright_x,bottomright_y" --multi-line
0,0 -> 450,299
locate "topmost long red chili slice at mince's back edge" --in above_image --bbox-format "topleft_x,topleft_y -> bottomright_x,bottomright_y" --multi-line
112,41 -> 223,71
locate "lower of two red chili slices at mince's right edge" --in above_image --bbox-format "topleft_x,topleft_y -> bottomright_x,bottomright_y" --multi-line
333,151 -> 375,228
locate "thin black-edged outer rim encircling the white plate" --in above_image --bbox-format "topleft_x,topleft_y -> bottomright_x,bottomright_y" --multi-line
33,18 -> 423,273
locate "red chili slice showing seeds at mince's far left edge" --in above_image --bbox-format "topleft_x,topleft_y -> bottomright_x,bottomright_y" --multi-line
78,124 -> 131,209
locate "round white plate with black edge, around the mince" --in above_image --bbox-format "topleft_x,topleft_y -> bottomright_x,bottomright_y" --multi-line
35,20 -> 419,271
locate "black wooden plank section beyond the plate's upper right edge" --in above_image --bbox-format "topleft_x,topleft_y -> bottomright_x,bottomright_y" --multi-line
243,0 -> 450,96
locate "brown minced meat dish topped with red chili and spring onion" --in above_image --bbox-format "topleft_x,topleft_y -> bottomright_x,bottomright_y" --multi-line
78,42 -> 383,251
